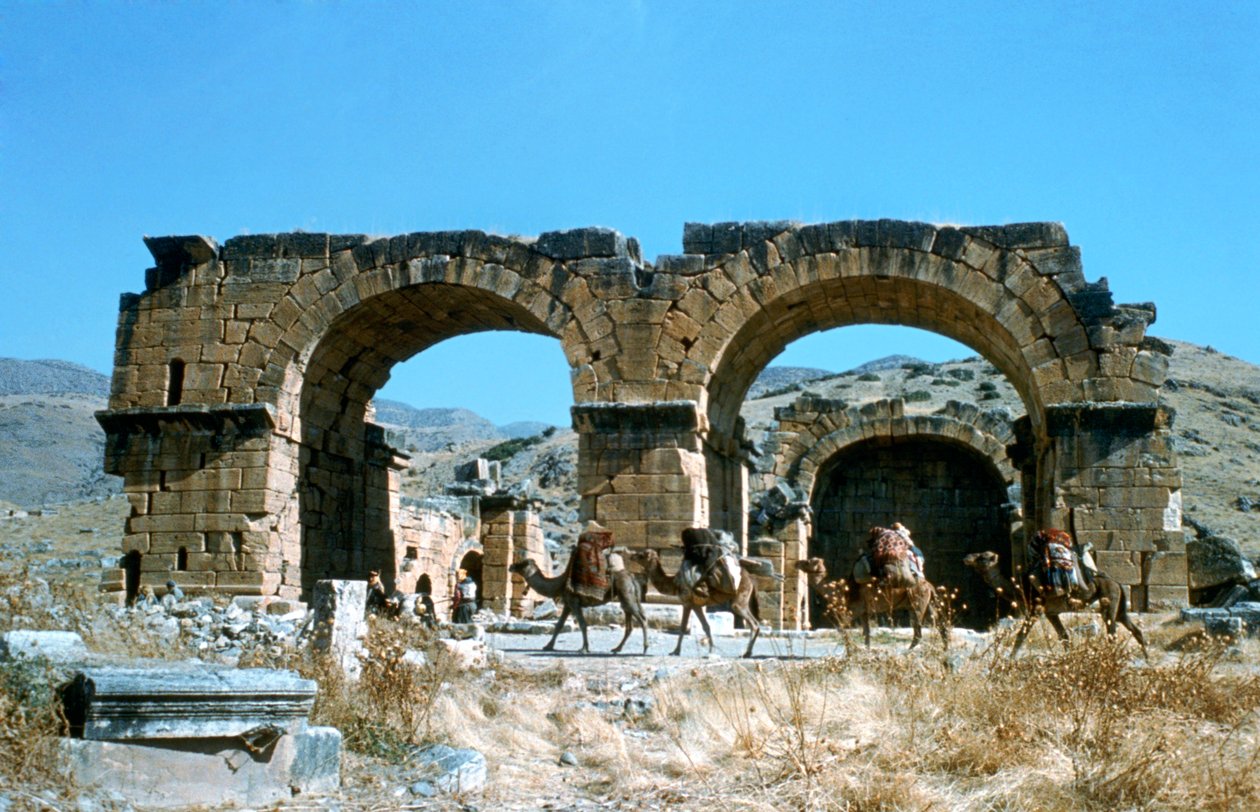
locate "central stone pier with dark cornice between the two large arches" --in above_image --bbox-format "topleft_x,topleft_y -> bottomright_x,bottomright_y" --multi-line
572,401 -> 709,548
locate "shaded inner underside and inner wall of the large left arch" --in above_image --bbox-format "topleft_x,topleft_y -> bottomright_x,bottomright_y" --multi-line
286,282 -> 563,594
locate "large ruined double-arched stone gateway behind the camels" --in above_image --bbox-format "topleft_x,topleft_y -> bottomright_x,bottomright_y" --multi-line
100,221 -> 1186,622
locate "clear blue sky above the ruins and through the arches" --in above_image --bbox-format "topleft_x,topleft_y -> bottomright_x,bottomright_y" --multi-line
0,0 -> 1260,424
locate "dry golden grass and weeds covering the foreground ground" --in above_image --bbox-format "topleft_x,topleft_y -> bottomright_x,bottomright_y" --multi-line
0,564 -> 1260,811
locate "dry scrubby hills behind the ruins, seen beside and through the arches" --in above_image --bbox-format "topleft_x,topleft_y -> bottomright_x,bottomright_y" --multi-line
0,340 -> 1260,564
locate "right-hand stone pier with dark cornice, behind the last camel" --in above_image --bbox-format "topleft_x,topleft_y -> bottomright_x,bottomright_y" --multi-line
1047,403 -> 1189,612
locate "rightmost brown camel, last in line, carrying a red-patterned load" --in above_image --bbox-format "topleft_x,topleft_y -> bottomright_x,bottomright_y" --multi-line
963,550 -> 1147,657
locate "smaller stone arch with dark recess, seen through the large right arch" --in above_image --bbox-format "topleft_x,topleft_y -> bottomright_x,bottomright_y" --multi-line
752,396 -> 1022,625
